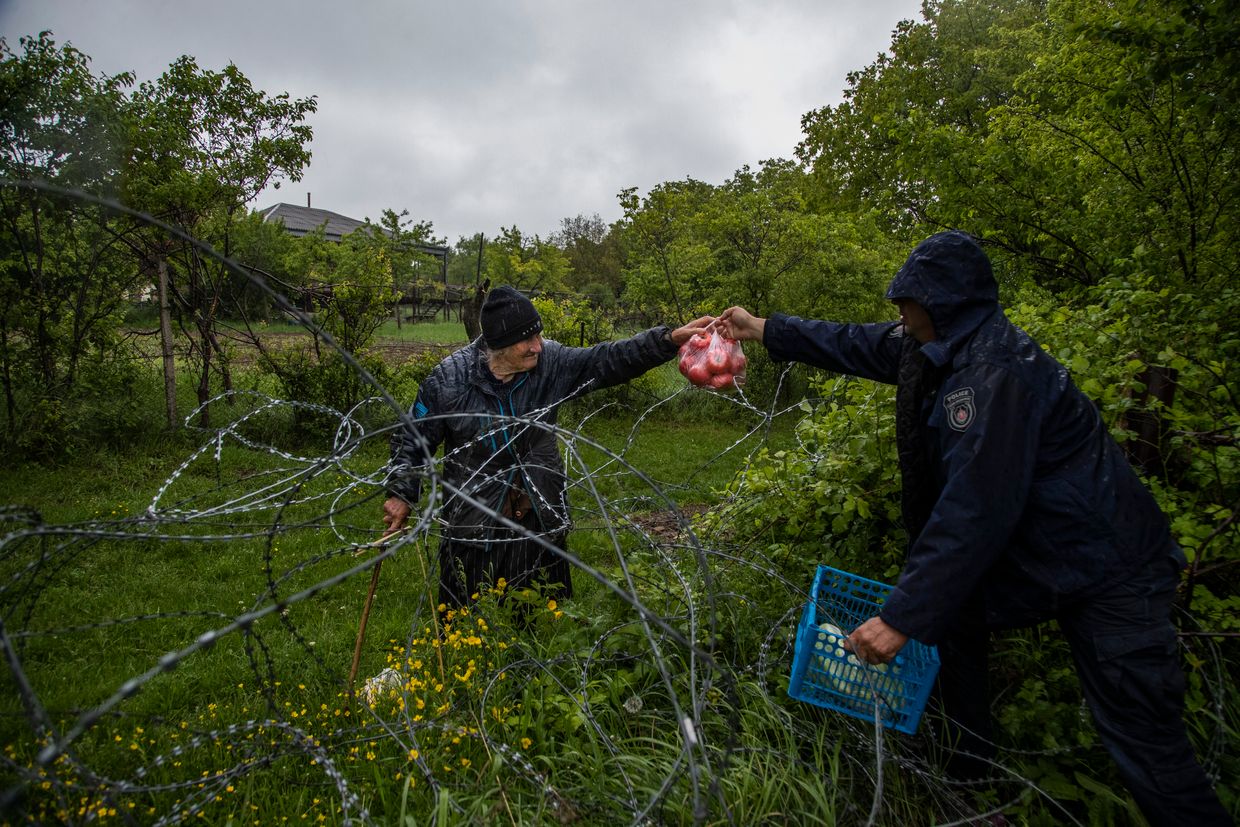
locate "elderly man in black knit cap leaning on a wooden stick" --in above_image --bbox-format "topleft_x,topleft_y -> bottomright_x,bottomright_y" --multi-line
383,286 -> 713,606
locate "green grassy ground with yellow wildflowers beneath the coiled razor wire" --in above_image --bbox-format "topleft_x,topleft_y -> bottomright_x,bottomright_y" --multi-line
7,334 -> 1208,827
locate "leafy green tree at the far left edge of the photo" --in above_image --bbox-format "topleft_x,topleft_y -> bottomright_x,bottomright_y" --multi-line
0,32 -> 136,451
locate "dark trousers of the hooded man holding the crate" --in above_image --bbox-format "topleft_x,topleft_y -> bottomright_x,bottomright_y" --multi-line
939,560 -> 1233,827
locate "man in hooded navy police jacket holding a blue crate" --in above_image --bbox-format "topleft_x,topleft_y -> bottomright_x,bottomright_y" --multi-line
719,232 -> 1231,827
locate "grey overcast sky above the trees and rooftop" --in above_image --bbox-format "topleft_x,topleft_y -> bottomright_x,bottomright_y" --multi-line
0,0 -> 920,243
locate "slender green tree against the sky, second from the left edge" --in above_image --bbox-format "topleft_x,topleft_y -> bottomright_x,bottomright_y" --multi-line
124,56 -> 316,427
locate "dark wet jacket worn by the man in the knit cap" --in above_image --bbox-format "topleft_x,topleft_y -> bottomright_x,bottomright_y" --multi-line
387,326 -> 677,544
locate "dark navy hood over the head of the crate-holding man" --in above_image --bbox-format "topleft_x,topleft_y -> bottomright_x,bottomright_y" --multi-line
887,229 -> 999,365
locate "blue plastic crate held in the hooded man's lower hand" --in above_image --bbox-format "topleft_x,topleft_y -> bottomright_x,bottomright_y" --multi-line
787,565 -> 939,734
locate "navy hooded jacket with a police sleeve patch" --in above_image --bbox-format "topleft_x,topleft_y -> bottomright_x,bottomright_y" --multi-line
764,232 -> 1184,643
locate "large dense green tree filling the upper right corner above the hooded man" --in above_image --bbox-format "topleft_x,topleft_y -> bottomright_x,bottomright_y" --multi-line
799,0 -> 1240,296
